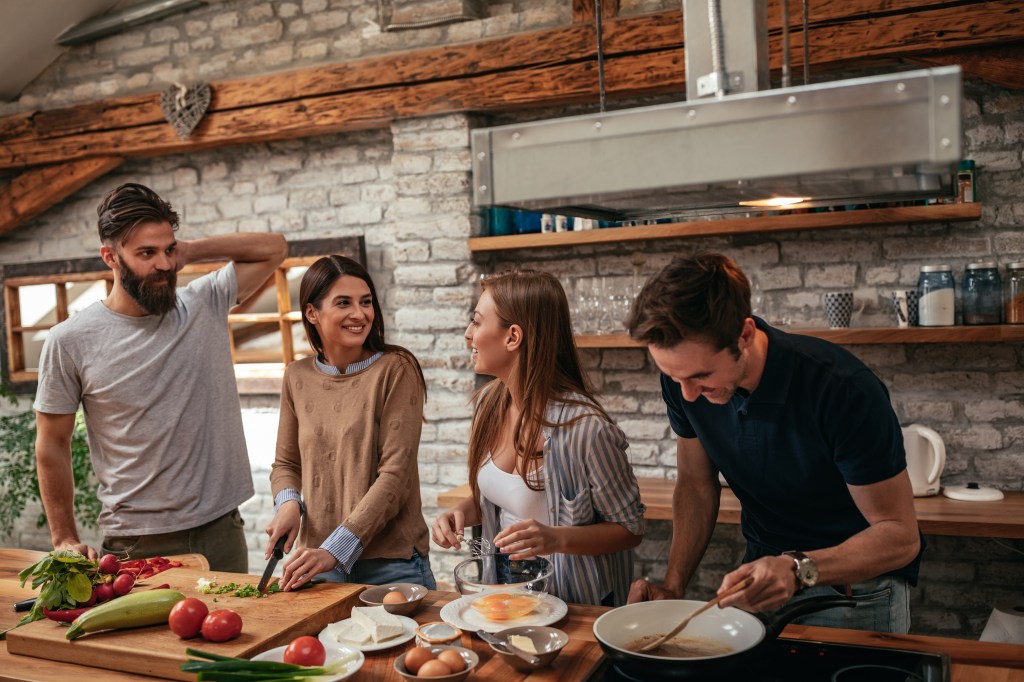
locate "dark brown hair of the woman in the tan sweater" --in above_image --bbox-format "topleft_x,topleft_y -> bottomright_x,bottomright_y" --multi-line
299,255 -> 427,393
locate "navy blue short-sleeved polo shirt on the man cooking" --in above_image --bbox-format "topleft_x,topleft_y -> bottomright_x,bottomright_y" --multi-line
662,317 -> 924,585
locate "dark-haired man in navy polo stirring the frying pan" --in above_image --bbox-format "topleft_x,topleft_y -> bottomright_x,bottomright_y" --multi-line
627,254 -> 924,633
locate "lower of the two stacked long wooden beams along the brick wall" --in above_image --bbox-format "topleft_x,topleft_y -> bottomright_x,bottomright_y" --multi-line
0,0 -> 1024,169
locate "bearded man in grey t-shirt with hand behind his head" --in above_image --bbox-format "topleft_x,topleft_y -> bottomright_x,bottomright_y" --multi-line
33,183 -> 288,572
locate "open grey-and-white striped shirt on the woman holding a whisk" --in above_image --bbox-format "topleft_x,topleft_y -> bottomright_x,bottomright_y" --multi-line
480,395 -> 644,606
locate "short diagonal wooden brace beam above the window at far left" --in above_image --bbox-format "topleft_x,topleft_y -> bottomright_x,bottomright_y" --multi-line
0,157 -> 124,235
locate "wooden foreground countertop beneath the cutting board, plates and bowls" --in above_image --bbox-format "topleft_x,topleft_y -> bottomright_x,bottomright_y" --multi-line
0,549 -> 1024,682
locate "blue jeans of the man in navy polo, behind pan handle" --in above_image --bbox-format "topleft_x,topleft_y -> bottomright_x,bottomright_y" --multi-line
790,576 -> 910,635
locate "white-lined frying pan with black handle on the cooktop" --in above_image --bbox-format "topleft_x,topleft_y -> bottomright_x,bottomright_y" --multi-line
594,595 -> 857,680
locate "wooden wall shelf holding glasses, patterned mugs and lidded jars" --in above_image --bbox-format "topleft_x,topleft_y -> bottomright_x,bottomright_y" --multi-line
575,325 -> 1024,348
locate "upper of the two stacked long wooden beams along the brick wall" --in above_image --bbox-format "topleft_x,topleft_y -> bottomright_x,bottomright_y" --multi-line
0,0 -> 1024,151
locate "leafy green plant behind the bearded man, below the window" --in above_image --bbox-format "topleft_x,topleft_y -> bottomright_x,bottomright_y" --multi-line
0,382 -> 100,538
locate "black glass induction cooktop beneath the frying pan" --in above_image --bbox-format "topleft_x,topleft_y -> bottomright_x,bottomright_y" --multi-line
588,639 -> 949,682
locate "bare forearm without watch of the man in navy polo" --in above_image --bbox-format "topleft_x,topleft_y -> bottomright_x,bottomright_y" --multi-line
665,481 -> 721,597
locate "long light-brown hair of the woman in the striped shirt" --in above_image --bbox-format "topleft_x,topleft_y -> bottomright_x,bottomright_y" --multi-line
469,269 -> 610,502
